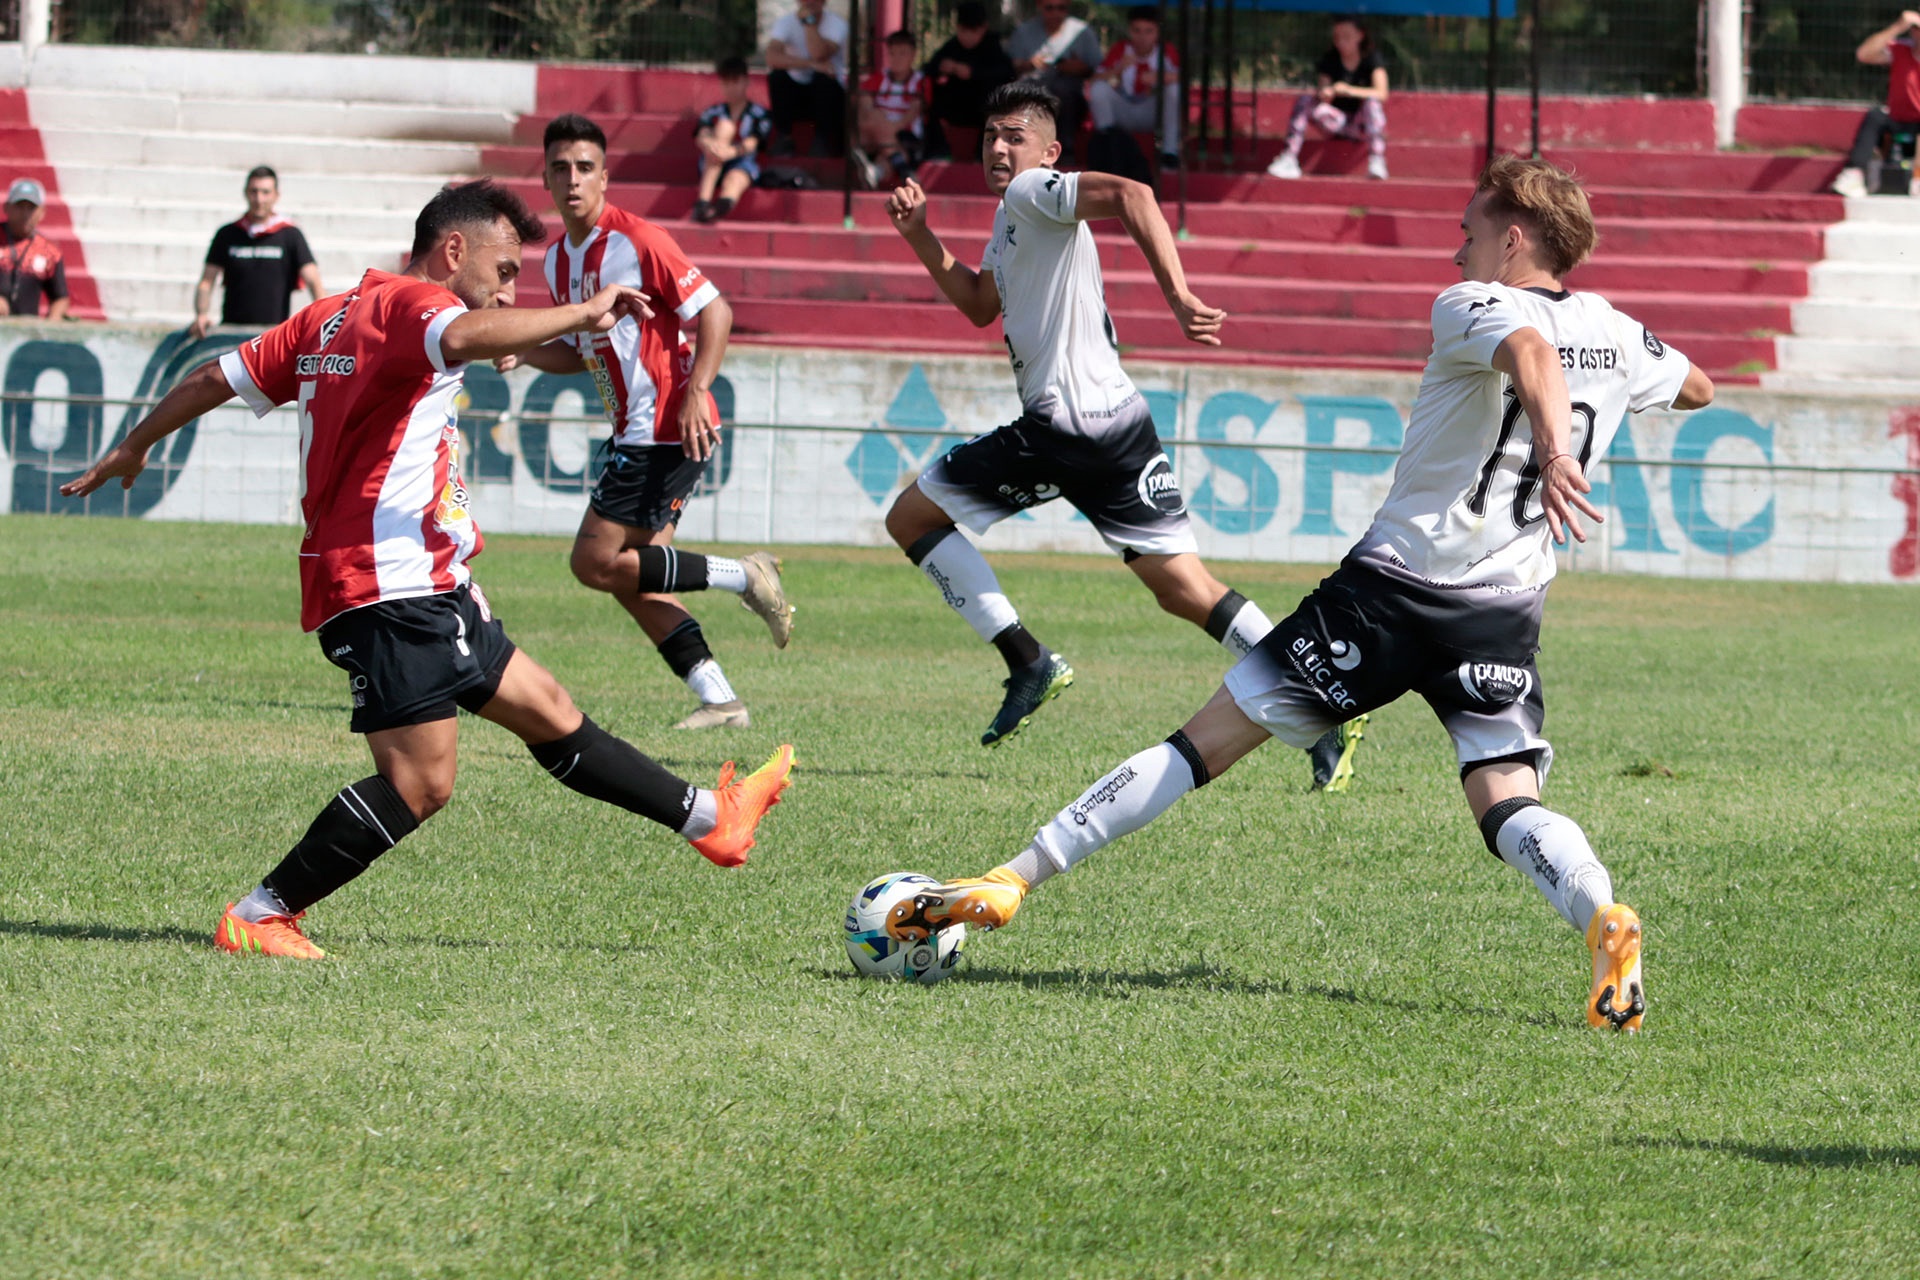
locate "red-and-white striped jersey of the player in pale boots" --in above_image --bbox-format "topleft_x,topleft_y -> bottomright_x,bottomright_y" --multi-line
547,203 -> 720,445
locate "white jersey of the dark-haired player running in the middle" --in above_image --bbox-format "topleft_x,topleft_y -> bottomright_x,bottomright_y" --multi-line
979,169 -> 1139,436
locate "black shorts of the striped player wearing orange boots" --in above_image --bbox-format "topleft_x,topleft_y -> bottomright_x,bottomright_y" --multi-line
319,583 -> 515,733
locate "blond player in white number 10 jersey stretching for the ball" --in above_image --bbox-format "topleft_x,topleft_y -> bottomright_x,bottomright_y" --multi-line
887,155 -> 1713,1031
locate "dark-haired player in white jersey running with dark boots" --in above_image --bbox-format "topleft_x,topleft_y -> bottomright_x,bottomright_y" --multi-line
887,81 -> 1357,782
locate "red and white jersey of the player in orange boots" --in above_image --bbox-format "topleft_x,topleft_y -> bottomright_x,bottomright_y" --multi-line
221,271 -> 482,631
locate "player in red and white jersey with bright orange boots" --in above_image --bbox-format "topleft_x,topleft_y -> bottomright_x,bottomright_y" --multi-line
61,180 -> 793,960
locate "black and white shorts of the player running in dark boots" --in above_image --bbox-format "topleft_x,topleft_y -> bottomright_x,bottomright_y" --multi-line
920,401 -> 1198,555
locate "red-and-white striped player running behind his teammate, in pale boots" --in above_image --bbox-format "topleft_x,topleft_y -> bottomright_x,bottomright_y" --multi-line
501,115 -> 793,729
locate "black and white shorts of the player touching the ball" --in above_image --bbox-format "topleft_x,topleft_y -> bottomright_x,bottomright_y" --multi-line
1225,562 -> 1553,781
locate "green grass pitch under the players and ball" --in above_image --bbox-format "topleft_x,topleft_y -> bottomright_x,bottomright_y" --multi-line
0,516 -> 1920,1280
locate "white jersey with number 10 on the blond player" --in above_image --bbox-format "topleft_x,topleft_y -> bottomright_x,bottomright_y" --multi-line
1354,284 -> 1692,591
